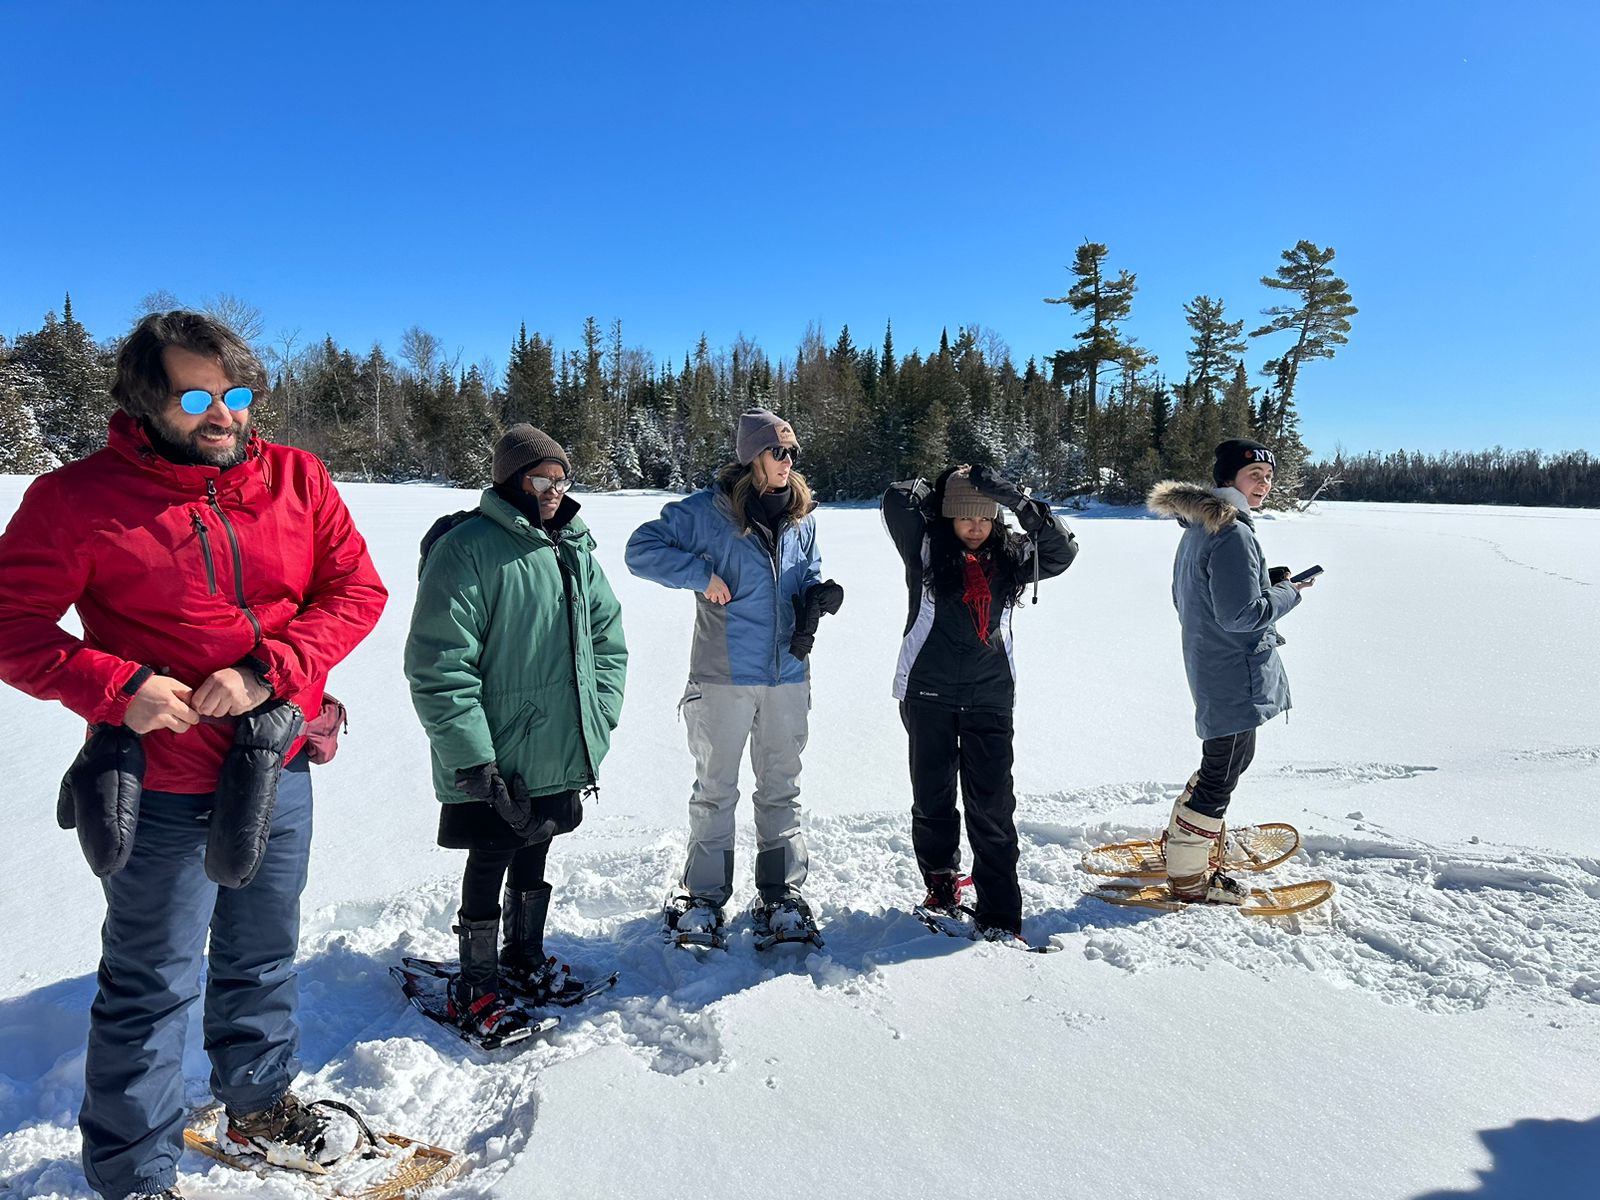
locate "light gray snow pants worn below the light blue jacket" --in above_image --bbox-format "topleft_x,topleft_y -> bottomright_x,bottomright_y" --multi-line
678,678 -> 811,907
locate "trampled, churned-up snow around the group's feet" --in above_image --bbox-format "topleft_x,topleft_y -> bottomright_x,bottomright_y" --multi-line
0,755 -> 1600,1197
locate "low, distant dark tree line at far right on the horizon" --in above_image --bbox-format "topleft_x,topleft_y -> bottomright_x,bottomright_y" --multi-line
1309,446 -> 1600,509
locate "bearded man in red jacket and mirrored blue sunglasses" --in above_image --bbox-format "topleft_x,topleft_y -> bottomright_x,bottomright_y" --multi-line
0,312 -> 387,1200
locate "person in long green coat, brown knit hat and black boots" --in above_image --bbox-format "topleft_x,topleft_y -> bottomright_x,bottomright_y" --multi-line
405,424 -> 627,1040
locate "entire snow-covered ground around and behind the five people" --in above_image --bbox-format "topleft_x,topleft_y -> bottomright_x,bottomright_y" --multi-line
0,478 -> 1600,1200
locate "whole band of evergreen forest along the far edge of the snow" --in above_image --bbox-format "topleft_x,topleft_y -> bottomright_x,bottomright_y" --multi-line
0,242 -> 1600,506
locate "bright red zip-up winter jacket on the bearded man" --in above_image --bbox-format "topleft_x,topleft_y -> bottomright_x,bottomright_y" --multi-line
0,411 -> 389,792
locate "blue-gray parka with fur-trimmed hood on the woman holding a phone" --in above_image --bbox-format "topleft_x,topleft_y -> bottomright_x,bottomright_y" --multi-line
1149,480 -> 1301,739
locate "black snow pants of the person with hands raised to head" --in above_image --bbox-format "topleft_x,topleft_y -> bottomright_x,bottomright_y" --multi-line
901,701 -> 1022,934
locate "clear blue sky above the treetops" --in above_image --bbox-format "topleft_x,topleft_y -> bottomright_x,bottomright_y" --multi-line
0,0 -> 1600,451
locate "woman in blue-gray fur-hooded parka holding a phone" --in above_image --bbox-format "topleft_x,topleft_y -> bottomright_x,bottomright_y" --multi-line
1149,437 -> 1310,904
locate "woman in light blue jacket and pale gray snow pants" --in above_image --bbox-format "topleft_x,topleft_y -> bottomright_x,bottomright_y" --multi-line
627,410 -> 843,944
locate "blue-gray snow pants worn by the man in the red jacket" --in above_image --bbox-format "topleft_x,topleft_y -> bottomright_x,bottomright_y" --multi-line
78,754 -> 312,1200
